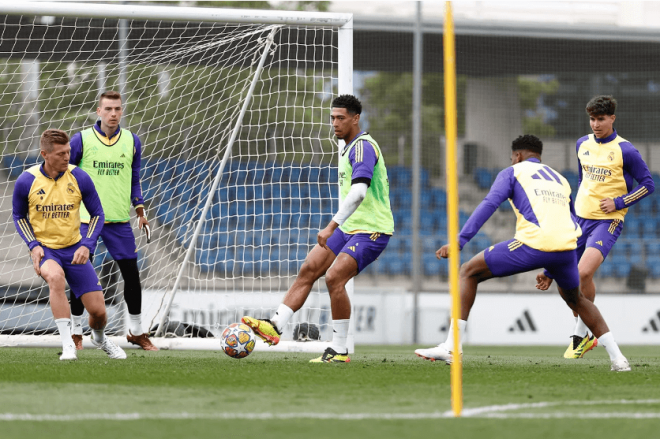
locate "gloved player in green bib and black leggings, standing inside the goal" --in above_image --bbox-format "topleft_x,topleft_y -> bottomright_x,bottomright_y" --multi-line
71,91 -> 158,351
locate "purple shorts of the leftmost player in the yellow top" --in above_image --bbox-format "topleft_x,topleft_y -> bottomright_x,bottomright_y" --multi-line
40,242 -> 103,298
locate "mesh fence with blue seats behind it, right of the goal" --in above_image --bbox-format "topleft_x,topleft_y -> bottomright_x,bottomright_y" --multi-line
342,17 -> 660,300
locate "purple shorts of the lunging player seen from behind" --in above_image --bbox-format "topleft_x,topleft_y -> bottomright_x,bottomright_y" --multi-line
484,239 -> 580,290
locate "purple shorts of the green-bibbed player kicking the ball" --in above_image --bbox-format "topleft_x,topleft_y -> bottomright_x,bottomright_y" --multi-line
327,228 -> 390,273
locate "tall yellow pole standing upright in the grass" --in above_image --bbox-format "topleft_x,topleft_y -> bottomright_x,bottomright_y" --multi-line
443,1 -> 463,417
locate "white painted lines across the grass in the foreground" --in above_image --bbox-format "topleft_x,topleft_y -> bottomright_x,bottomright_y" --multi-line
0,399 -> 660,422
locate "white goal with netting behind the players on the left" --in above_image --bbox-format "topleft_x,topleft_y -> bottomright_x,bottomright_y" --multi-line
0,3 -> 352,350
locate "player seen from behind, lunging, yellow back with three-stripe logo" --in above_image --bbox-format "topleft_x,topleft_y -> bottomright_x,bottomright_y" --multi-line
415,135 -> 630,372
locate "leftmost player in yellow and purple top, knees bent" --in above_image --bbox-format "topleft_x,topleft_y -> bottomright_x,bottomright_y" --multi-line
12,130 -> 126,360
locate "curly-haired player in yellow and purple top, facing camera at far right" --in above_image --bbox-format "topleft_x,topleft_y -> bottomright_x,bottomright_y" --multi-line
537,96 -> 655,358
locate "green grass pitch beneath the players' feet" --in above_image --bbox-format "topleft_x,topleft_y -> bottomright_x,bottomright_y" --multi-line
0,346 -> 660,439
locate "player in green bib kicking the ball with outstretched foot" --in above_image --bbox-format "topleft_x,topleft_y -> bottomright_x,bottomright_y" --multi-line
242,95 -> 394,363
